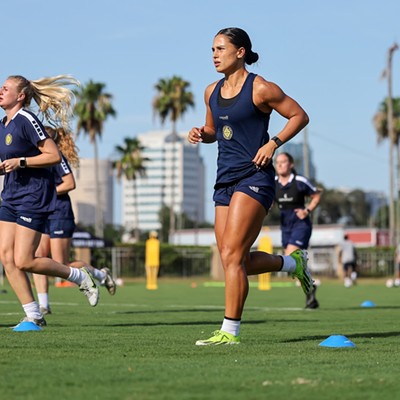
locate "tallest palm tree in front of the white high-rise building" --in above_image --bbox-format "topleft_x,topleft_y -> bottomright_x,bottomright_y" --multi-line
153,76 -> 194,239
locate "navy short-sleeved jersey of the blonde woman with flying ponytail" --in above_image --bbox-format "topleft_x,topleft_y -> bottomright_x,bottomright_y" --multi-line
0,109 -> 56,213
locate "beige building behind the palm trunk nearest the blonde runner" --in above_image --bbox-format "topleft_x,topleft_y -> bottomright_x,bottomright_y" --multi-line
69,158 -> 114,226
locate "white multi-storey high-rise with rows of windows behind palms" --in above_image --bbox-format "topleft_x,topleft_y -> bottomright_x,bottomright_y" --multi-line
121,131 -> 205,231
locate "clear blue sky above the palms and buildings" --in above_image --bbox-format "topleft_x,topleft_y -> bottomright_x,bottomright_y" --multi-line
0,0 -> 400,222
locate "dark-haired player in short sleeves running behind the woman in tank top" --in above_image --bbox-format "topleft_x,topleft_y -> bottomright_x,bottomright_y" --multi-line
275,153 -> 321,308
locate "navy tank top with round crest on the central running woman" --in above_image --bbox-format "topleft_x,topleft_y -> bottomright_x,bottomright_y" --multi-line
210,73 -> 273,187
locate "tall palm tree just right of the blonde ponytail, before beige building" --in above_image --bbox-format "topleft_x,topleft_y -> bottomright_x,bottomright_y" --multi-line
74,80 -> 116,237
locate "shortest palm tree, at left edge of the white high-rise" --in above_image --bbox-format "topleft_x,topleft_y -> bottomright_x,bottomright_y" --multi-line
113,138 -> 149,242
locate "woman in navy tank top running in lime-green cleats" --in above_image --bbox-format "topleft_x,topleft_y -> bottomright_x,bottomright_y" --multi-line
188,28 -> 312,346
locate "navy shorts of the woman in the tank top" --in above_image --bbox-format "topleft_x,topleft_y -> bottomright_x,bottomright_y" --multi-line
213,169 -> 275,213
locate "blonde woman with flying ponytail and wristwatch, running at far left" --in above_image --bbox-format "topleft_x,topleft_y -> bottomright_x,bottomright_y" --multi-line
0,75 -> 99,326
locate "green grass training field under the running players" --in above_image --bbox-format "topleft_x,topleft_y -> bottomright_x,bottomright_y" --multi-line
0,280 -> 400,400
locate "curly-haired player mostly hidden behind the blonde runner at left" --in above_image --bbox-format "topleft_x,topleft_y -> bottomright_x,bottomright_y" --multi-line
33,126 -> 116,315
